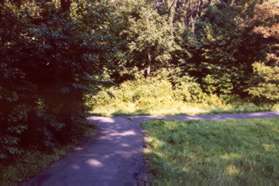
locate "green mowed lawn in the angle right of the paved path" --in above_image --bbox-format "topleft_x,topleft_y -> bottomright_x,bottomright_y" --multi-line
144,118 -> 279,186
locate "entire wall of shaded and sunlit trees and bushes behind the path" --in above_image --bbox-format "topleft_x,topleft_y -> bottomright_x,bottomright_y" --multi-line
0,0 -> 279,159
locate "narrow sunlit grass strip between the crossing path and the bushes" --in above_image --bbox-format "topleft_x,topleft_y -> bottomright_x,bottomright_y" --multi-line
90,102 -> 279,116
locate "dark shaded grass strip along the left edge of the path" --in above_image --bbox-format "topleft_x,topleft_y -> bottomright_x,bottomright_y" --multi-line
0,125 -> 95,186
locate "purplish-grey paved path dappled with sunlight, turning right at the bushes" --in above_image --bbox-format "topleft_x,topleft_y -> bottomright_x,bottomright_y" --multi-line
22,112 -> 279,186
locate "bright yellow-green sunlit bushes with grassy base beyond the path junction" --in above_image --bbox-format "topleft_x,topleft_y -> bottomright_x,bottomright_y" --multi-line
87,77 -> 247,114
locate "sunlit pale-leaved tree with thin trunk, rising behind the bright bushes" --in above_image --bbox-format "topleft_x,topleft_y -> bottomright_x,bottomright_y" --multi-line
127,4 -> 175,77
